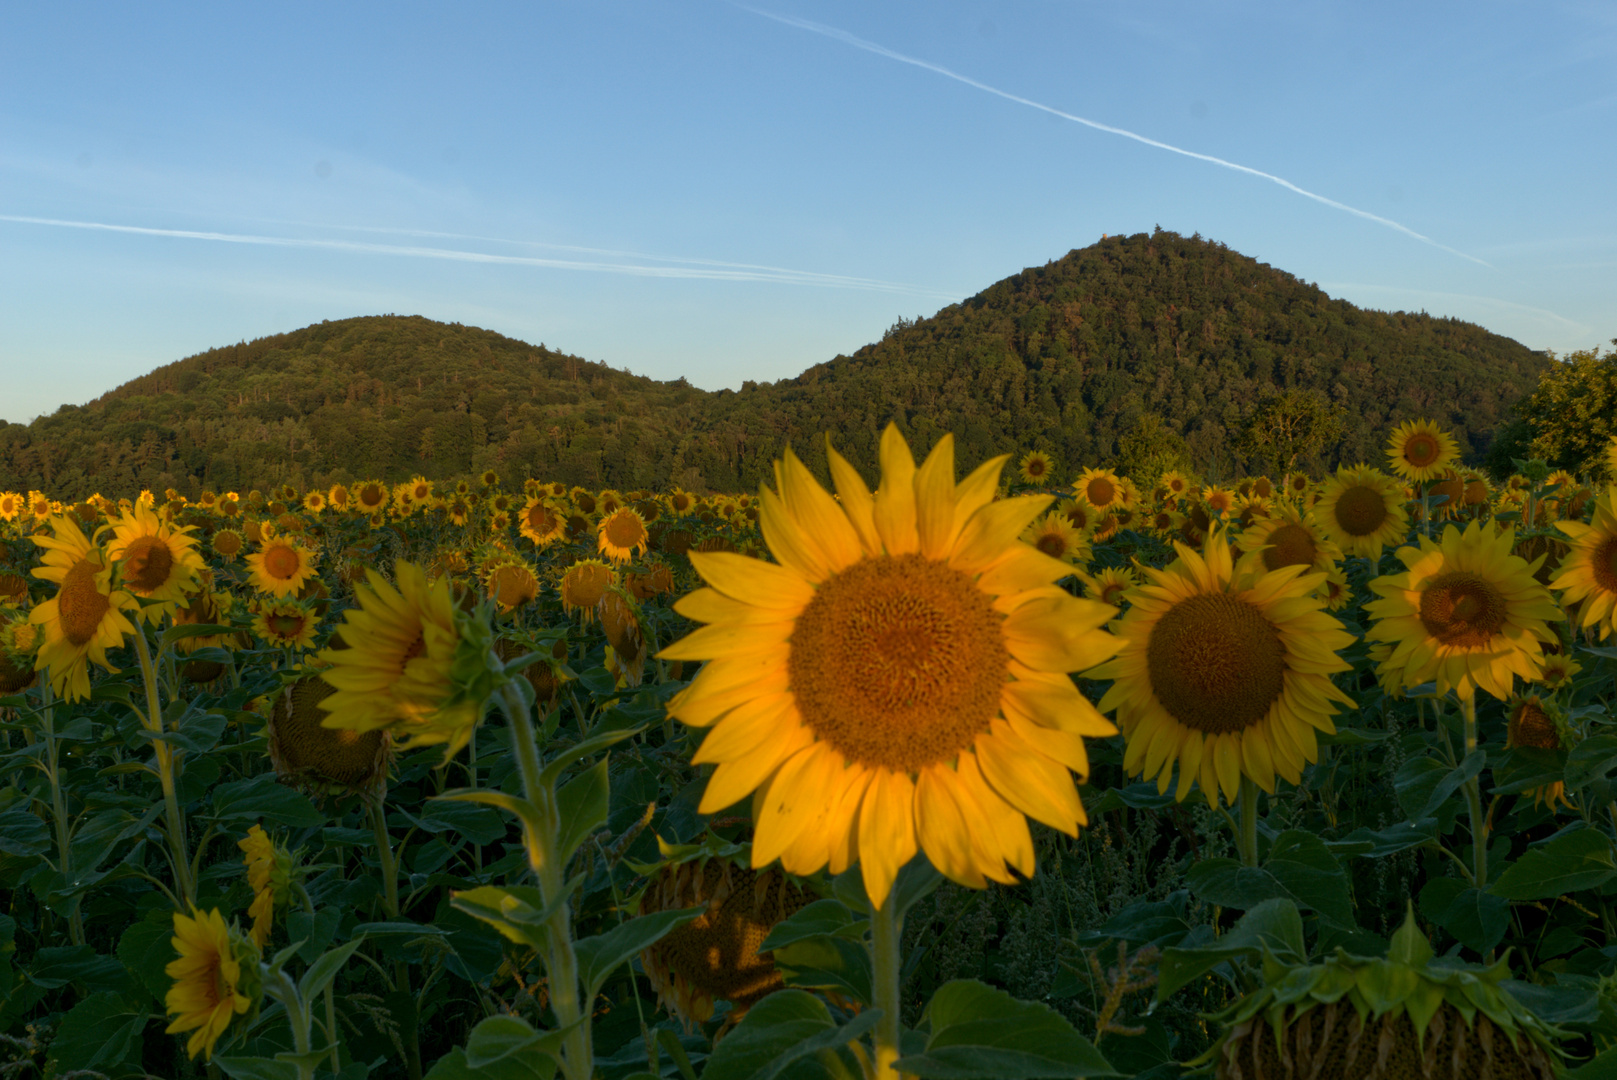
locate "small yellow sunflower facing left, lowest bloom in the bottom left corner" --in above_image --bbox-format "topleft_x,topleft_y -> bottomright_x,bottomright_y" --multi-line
163,909 -> 259,1061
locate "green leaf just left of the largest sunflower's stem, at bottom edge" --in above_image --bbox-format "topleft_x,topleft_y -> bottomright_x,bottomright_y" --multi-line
702,989 -> 881,1080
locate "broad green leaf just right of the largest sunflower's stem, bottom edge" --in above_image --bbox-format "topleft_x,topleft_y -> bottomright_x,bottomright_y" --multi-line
894,978 -> 1121,1080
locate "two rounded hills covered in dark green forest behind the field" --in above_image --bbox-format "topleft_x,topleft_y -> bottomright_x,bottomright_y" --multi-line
0,231 -> 1549,496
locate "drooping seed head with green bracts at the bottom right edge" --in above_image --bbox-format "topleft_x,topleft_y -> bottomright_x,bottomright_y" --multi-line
1209,910 -> 1560,1080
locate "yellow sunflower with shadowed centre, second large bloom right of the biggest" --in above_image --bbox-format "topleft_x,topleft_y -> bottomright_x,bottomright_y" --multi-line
1365,522 -> 1560,702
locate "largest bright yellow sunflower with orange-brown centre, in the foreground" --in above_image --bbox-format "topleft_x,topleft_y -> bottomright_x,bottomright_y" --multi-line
661,425 -> 1117,907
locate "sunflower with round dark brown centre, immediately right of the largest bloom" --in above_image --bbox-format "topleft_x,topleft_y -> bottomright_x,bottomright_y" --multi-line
1088,530 -> 1353,807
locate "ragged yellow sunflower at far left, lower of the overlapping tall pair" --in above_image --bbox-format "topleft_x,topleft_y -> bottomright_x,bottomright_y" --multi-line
29,517 -> 139,702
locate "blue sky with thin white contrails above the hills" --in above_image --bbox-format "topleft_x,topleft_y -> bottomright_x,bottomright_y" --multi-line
0,0 -> 1617,420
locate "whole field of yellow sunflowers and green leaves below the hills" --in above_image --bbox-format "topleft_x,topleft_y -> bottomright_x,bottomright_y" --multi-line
0,422 -> 1617,1080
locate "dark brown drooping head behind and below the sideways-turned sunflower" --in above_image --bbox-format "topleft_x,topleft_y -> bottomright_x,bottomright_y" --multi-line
265,669 -> 393,797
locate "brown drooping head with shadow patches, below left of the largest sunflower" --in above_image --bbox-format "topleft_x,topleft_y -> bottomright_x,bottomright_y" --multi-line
640,852 -> 815,1028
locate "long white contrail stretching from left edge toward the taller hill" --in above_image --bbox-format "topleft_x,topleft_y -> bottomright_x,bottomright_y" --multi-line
0,213 -> 959,301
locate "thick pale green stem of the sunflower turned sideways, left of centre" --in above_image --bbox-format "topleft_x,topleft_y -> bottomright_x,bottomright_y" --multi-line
500,686 -> 595,1080
